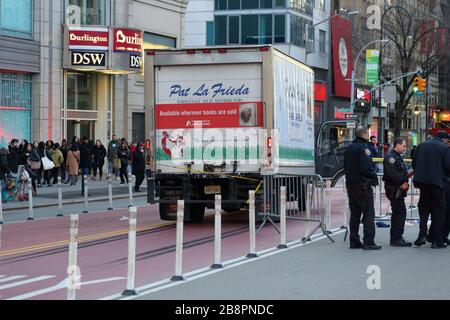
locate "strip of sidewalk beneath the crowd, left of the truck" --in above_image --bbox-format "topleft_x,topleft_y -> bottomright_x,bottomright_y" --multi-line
3,178 -> 147,211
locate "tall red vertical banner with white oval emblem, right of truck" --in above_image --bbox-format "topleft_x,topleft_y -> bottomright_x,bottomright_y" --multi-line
331,17 -> 353,98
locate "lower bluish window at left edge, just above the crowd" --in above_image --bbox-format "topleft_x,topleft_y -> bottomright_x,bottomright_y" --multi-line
0,73 -> 32,146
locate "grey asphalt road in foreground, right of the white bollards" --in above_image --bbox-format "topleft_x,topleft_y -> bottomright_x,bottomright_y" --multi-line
134,225 -> 450,300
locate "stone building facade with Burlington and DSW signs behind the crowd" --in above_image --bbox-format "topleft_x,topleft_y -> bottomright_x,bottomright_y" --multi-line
0,0 -> 187,145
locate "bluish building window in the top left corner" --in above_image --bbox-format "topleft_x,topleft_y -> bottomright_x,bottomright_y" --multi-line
0,0 -> 33,39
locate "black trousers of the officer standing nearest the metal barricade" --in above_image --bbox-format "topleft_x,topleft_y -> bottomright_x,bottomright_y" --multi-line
347,185 -> 375,245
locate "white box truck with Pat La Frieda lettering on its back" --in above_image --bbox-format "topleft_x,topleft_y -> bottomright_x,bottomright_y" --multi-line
145,46 -> 356,222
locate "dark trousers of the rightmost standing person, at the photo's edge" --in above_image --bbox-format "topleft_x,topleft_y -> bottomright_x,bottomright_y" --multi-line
418,185 -> 445,243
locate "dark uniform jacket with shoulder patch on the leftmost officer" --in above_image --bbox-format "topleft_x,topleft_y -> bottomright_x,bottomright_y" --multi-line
344,138 -> 378,186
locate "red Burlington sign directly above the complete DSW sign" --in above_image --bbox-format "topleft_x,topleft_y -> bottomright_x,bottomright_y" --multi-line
69,27 -> 109,51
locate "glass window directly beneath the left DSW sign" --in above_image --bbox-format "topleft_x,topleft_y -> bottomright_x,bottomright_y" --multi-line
67,72 -> 98,111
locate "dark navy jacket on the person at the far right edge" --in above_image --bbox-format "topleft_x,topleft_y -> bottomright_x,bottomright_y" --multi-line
412,138 -> 450,189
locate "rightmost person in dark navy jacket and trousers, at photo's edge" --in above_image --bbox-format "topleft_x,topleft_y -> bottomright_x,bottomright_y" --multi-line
412,132 -> 450,248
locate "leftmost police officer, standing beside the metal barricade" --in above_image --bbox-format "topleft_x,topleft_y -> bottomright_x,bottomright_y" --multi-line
344,127 -> 381,250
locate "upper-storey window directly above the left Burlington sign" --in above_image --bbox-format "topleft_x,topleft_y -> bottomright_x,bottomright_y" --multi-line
66,0 -> 107,25
